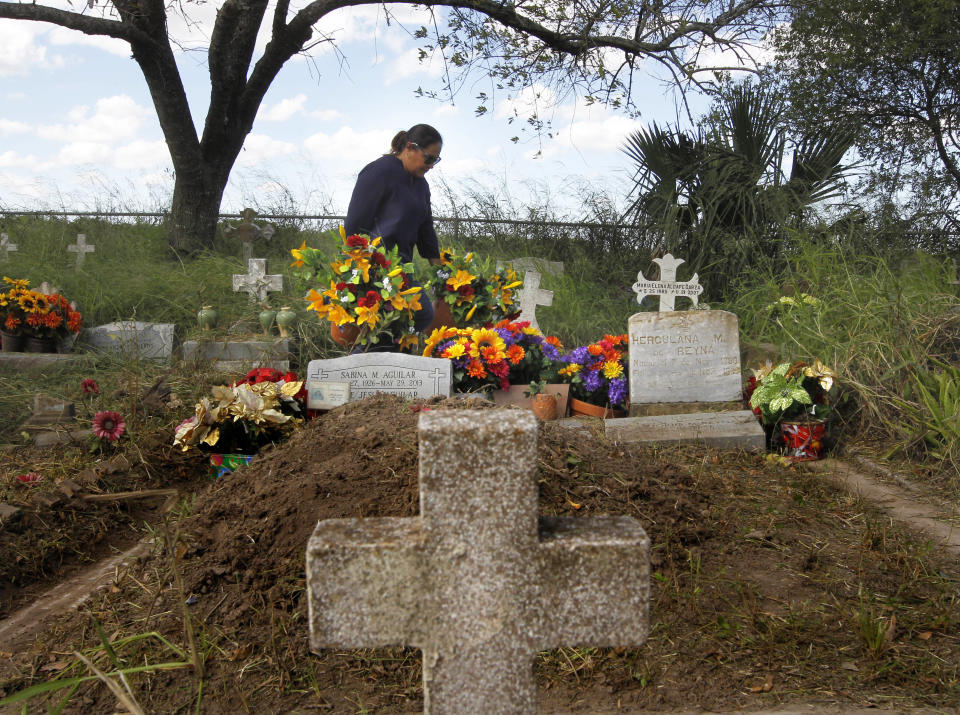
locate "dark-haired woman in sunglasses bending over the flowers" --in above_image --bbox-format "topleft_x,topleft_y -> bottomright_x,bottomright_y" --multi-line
344,124 -> 443,342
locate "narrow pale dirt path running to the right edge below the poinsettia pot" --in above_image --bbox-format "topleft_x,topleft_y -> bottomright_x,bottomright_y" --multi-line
805,459 -> 960,557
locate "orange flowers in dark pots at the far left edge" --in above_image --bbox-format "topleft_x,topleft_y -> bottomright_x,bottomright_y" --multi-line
0,276 -> 82,338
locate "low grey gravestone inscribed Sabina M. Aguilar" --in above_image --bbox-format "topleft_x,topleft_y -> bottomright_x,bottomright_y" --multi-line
307,353 -> 453,410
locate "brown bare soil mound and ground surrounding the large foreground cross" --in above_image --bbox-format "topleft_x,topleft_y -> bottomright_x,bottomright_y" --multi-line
0,396 -> 960,713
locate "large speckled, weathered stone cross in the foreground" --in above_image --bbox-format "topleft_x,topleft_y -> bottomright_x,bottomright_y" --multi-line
307,410 -> 650,714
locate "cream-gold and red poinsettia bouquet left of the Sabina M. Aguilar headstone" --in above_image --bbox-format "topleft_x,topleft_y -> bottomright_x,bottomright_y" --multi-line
173,368 -> 305,454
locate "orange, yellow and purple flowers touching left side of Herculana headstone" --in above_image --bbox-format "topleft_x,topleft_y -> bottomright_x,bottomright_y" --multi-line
559,334 -> 628,409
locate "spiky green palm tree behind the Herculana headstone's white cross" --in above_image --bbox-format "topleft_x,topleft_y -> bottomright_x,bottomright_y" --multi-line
623,83 -> 853,290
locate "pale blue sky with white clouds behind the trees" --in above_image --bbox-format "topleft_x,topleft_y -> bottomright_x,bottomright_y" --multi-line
0,2 -> 748,219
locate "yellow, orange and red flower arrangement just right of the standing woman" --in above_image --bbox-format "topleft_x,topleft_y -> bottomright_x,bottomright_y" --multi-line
426,248 -> 523,327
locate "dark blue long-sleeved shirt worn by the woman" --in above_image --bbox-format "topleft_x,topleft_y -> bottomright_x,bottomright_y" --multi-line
344,154 -> 440,262
